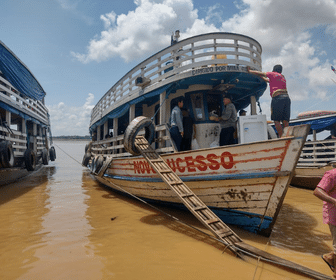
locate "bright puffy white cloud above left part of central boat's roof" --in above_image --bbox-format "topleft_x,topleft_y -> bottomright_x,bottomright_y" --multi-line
72,0 -> 197,63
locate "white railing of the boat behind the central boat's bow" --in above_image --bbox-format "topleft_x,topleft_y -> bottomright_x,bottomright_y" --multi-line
297,139 -> 336,167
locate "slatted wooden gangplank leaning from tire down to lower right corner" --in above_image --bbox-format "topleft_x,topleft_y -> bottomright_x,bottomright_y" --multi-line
134,136 -> 333,280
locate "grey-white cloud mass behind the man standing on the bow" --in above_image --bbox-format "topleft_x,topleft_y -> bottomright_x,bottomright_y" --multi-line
221,0 -> 336,115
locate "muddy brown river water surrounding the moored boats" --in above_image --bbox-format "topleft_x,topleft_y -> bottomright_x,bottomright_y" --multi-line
0,141 -> 332,280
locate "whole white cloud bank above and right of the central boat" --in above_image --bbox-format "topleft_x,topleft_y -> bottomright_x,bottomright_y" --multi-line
71,0 -> 336,122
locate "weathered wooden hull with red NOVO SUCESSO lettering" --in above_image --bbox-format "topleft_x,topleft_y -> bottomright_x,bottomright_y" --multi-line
91,124 -> 307,236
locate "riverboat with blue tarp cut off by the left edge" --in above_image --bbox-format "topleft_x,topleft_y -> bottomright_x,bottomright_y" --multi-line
0,41 -> 56,185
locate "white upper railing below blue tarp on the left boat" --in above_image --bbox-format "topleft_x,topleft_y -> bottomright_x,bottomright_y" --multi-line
0,76 -> 50,125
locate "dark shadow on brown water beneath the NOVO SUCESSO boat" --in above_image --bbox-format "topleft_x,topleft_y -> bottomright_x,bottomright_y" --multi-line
93,178 -> 331,255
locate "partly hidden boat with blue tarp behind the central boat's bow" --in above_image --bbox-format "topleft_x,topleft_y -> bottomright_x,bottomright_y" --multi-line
290,110 -> 336,189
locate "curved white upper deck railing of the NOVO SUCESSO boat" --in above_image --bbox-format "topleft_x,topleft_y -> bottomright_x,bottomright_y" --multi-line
90,33 -> 262,126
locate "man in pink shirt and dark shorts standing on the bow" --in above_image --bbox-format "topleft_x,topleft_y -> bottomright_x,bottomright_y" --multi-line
247,65 -> 291,137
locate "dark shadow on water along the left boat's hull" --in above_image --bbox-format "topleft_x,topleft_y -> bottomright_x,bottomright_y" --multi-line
0,166 -> 56,205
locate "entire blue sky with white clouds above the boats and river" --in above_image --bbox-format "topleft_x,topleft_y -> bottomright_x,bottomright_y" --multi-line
0,0 -> 336,136
